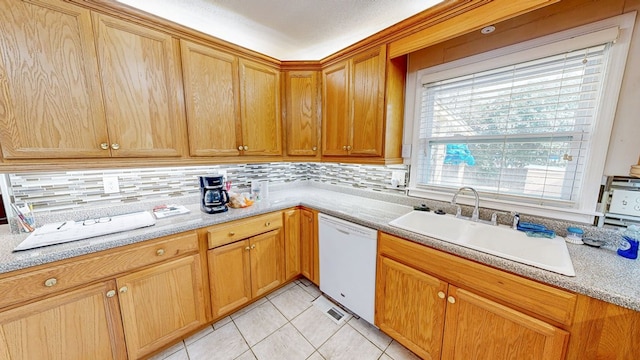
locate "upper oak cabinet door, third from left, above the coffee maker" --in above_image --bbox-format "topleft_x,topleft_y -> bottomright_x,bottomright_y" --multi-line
180,40 -> 242,156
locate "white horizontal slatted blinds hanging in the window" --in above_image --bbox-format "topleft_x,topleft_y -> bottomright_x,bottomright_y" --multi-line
416,44 -> 610,207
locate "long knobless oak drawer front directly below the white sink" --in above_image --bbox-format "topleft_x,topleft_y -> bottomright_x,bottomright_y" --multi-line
378,233 -> 577,325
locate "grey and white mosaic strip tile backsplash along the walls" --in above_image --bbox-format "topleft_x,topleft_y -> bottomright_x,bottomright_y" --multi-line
8,162 -> 408,212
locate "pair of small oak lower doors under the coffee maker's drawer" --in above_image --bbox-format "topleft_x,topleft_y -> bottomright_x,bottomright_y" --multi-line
208,229 -> 284,318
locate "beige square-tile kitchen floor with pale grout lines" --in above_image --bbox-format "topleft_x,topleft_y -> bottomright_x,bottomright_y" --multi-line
153,279 -> 419,360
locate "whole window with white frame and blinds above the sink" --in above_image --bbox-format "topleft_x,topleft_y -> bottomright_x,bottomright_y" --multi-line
410,14 -> 633,221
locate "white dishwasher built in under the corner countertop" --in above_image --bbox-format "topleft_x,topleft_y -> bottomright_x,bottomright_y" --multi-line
318,214 -> 378,324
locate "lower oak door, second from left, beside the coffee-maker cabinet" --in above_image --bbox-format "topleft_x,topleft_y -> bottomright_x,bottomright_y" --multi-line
117,254 -> 206,359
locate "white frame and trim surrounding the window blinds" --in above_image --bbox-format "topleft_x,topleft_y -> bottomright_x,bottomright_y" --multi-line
405,12 -> 636,223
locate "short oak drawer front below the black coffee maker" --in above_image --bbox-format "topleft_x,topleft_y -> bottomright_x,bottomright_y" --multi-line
208,212 -> 282,249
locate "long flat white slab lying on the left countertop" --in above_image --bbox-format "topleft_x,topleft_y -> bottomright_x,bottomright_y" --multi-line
13,211 -> 156,251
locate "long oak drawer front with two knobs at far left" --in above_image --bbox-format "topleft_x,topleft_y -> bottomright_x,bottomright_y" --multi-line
0,231 -> 198,308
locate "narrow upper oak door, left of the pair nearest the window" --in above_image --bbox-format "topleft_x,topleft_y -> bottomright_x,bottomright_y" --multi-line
322,61 -> 351,156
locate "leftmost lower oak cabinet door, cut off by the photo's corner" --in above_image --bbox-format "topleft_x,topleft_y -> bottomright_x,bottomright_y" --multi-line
0,281 -> 127,360
